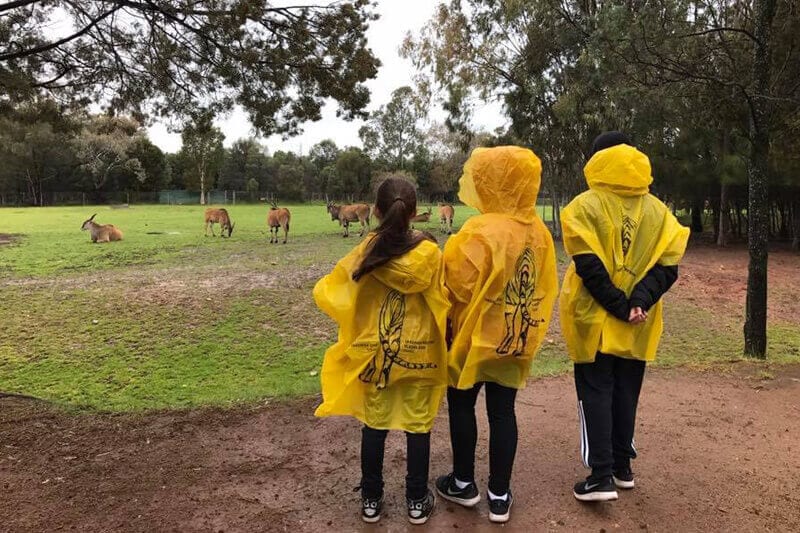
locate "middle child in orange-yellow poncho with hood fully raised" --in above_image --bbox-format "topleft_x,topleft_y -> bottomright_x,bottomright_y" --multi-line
436,146 -> 558,522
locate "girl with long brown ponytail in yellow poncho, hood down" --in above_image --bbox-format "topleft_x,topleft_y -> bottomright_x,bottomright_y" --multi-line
314,178 -> 450,524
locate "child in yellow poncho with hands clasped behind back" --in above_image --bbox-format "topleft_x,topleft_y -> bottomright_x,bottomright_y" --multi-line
559,132 -> 689,501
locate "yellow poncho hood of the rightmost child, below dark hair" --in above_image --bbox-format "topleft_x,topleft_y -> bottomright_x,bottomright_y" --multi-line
583,144 -> 653,196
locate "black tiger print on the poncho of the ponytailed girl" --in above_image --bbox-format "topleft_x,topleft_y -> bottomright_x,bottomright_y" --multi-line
358,290 -> 436,389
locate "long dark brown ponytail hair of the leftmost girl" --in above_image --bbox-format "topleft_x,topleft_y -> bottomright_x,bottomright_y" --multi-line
353,177 -> 436,281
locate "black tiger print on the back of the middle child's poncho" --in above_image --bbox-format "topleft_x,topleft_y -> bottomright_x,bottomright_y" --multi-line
497,248 -> 544,357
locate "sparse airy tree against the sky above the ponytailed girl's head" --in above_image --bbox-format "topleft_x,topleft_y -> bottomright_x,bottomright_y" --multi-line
358,86 -> 426,170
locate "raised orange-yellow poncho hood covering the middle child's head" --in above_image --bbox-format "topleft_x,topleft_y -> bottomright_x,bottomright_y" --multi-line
458,146 -> 542,221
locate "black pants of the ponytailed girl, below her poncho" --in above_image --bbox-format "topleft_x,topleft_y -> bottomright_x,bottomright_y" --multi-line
361,426 -> 431,500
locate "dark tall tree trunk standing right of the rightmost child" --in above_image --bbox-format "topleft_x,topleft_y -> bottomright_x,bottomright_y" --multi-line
744,0 -> 777,359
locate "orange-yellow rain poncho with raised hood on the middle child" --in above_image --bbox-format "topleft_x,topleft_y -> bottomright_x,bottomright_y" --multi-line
444,146 -> 558,389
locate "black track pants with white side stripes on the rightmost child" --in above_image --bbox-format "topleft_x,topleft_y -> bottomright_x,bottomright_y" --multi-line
575,353 -> 645,480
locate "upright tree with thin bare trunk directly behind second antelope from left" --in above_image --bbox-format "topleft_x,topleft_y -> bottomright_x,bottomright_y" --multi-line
181,112 -> 225,205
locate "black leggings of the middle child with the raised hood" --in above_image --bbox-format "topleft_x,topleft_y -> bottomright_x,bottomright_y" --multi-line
447,382 -> 517,496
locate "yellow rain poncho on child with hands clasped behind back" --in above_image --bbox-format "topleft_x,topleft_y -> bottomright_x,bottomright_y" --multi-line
559,144 -> 689,363
